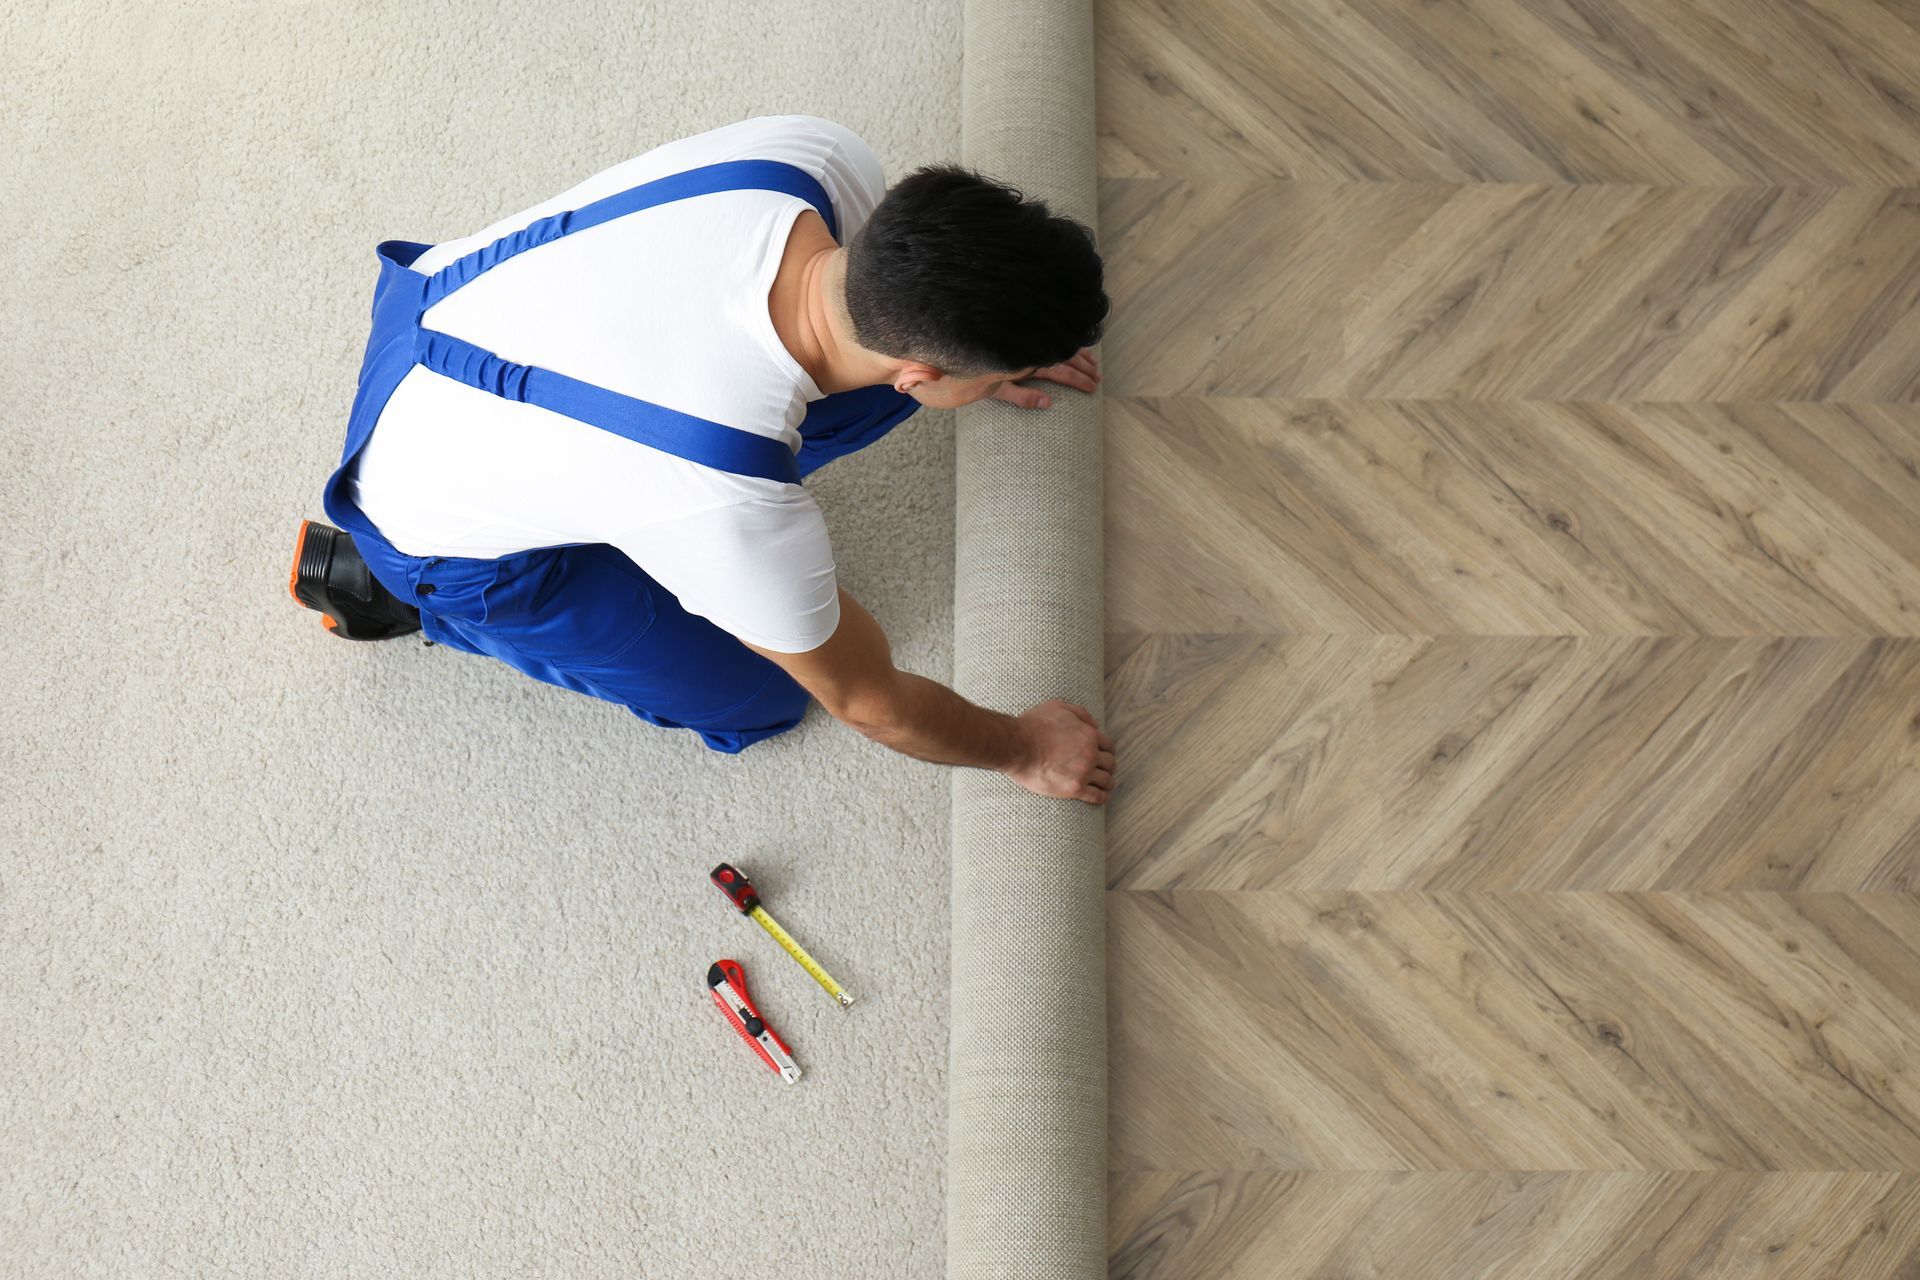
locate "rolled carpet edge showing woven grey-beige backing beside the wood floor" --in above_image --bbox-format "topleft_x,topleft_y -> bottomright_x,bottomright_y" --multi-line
947,0 -> 1106,1280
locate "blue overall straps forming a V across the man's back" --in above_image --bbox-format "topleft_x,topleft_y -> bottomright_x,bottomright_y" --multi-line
413,159 -> 839,484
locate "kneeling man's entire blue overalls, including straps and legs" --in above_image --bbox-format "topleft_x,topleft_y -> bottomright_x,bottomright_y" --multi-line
324,159 -> 918,754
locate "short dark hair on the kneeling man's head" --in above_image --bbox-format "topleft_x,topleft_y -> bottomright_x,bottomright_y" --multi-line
847,165 -> 1108,378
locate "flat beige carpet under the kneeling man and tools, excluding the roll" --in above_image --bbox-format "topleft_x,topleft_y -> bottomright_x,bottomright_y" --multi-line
0,0 -> 960,1280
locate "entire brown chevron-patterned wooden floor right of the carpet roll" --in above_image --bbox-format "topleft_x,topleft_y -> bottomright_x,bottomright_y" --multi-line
1096,0 -> 1920,1280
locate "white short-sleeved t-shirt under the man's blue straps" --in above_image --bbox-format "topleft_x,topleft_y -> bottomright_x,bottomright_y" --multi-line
351,115 -> 885,652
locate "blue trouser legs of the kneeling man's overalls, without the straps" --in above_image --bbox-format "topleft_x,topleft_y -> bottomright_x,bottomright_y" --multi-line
339,386 -> 918,754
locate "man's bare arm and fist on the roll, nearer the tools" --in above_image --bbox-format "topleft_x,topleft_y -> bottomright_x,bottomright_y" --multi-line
747,587 -> 1114,804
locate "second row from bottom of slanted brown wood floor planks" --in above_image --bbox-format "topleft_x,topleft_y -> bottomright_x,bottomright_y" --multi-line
1108,890 -> 1920,1173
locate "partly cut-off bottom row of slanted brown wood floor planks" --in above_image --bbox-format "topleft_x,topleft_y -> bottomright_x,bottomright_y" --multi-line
1108,1173 -> 1920,1280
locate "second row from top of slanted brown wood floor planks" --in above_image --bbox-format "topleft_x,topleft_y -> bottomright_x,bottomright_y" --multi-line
1102,178 -> 1920,403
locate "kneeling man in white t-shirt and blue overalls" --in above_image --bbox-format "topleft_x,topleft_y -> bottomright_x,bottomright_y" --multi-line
292,115 -> 1114,804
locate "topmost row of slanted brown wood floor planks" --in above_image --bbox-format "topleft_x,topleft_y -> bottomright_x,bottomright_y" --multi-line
1096,0 -> 1920,186
